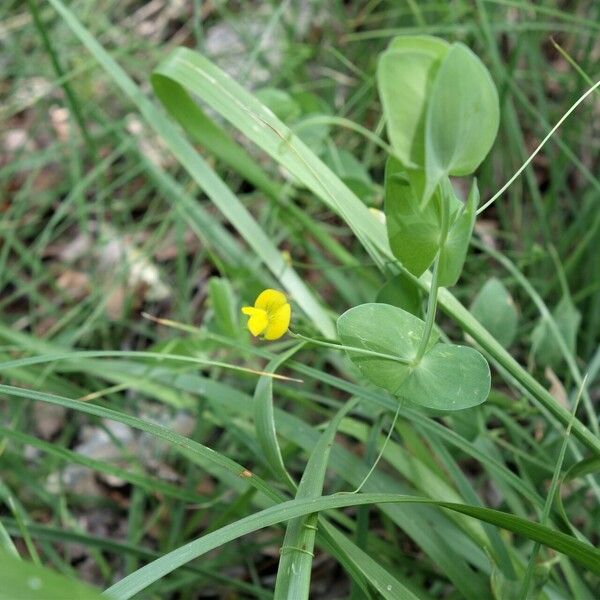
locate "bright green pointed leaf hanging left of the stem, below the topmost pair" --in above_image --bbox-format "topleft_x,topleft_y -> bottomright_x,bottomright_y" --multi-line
385,157 -> 441,277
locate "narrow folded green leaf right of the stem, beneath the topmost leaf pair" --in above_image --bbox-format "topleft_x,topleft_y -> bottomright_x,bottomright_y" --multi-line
438,181 -> 479,287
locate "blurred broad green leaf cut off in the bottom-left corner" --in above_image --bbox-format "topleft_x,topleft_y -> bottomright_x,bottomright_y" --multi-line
0,550 -> 103,600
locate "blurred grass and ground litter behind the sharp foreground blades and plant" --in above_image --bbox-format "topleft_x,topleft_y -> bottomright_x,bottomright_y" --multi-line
0,0 -> 600,597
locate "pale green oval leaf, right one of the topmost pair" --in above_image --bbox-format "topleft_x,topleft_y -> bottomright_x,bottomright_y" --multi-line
425,43 -> 500,198
